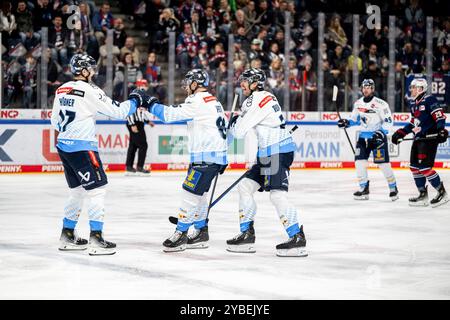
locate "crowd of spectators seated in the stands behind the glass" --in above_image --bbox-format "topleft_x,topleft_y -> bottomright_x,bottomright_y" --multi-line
1,0 -> 450,111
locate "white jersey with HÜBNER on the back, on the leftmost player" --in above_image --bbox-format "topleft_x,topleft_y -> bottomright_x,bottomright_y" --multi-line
51,80 -> 137,152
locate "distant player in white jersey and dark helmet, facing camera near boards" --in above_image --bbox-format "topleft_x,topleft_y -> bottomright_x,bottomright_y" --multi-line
338,79 -> 398,201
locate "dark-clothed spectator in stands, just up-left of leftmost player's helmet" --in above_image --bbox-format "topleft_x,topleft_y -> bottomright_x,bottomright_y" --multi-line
48,16 -> 69,67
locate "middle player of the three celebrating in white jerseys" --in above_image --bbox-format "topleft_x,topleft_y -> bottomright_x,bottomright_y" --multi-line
143,69 -> 227,252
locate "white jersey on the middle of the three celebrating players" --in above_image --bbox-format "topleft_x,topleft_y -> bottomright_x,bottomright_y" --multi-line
150,92 -> 228,164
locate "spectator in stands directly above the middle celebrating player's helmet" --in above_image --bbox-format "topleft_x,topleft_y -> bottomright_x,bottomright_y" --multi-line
177,23 -> 199,74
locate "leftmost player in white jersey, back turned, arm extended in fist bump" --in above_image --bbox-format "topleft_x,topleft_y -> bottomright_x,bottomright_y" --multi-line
51,54 -> 146,255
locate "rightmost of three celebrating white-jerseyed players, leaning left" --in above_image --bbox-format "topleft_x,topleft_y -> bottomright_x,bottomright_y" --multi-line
227,68 -> 308,257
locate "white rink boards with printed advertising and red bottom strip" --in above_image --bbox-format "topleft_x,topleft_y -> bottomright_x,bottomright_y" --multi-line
0,109 -> 450,173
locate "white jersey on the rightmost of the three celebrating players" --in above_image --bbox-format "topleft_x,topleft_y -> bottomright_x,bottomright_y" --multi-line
231,91 -> 296,157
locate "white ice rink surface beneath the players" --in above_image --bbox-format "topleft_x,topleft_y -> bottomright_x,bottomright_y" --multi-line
0,170 -> 450,299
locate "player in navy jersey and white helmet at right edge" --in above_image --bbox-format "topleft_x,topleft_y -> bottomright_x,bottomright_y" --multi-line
392,79 -> 449,207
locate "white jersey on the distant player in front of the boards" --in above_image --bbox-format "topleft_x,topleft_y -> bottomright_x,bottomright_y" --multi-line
350,97 -> 393,139
